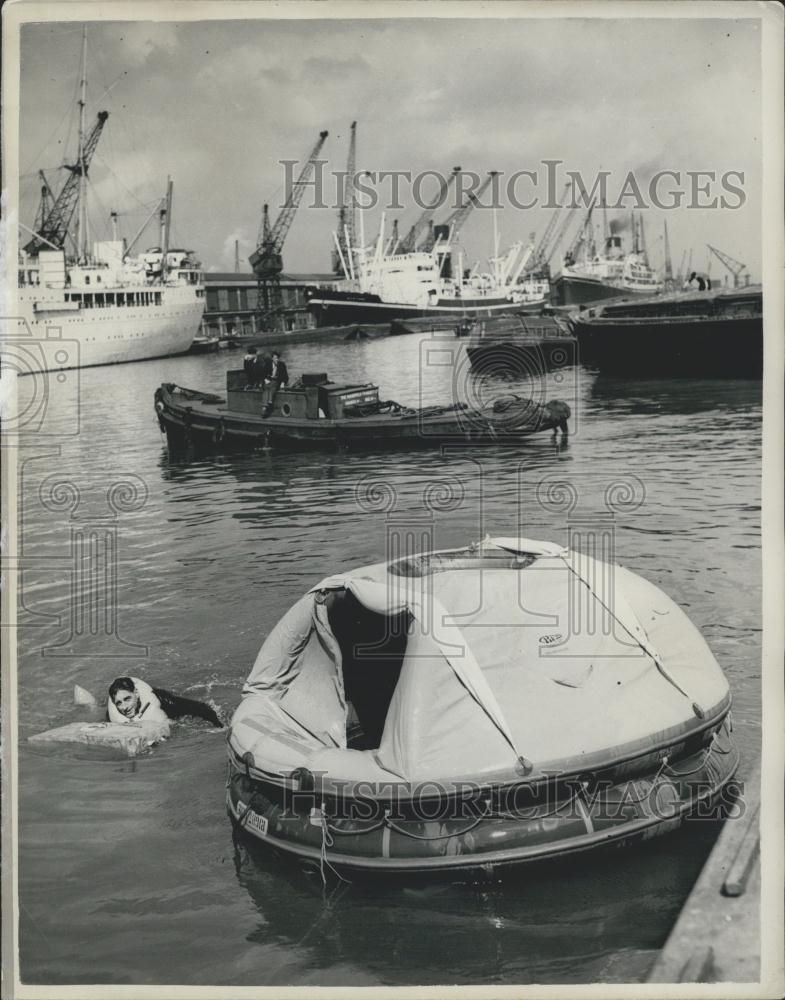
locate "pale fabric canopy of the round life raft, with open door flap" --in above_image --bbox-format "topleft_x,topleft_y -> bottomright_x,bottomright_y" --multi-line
230,538 -> 729,787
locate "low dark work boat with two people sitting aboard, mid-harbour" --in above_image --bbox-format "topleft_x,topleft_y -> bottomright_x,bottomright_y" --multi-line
155,370 -> 570,451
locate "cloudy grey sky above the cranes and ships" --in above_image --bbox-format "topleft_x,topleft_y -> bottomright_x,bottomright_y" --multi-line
20,12 -> 761,279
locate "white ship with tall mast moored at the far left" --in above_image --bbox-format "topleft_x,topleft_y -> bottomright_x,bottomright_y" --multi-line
14,33 -> 205,373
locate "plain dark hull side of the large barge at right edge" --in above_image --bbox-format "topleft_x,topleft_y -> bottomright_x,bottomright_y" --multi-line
574,316 -> 763,379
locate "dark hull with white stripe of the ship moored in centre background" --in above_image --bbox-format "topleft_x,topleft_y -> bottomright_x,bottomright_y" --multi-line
306,290 -> 545,327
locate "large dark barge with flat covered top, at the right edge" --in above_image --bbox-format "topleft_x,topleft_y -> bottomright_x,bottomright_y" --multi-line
572,285 -> 763,379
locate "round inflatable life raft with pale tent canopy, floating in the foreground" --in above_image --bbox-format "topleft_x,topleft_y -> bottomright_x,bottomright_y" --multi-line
227,538 -> 738,872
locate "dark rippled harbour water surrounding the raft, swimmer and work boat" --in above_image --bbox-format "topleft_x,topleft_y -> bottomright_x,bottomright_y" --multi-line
13,336 -> 761,986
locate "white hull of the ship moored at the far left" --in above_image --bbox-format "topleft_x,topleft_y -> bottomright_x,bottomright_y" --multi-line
14,286 -> 204,374
